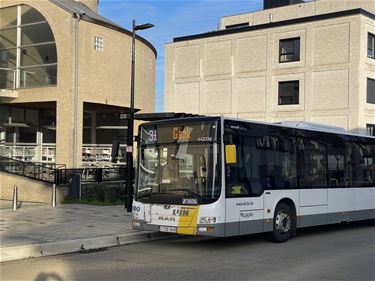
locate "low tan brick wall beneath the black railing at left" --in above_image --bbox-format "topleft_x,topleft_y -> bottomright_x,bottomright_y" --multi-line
0,172 -> 68,204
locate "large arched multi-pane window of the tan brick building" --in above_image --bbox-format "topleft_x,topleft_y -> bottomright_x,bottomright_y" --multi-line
0,5 -> 57,89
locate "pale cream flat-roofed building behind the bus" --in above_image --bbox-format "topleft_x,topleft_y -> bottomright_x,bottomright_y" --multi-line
164,0 -> 375,134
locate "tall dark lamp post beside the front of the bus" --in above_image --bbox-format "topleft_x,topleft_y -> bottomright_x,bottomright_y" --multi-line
126,19 -> 154,212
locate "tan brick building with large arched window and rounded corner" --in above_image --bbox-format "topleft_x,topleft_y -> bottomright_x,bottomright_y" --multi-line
0,0 -> 156,167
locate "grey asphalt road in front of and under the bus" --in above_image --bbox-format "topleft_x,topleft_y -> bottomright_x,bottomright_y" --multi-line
0,223 -> 375,281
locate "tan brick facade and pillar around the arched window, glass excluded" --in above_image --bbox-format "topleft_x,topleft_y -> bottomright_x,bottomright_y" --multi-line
0,0 -> 156,168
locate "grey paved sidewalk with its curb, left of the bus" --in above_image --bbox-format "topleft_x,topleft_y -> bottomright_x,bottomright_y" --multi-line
0,200 -> 171,262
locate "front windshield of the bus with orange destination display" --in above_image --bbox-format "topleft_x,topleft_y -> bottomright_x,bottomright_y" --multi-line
136,121 -> 221,205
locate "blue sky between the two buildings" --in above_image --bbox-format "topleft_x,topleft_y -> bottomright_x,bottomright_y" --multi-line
99,0 -> 263,112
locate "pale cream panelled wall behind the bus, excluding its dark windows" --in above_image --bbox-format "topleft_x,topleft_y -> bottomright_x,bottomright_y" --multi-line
165,10 -> 375,132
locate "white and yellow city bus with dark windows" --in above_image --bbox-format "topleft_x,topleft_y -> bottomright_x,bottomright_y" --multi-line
132,117 -> 375,242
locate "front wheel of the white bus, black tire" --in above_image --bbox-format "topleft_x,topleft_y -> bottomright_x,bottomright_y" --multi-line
270,202 -> 296,243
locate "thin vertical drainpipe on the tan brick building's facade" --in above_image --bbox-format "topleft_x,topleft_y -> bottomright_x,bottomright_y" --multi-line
72,13 -> 84,168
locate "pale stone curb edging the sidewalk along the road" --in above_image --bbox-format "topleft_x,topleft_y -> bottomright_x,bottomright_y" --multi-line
0,232 -> 178,262
